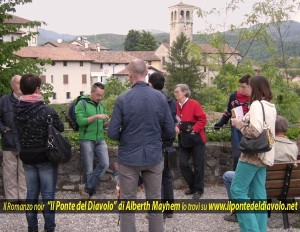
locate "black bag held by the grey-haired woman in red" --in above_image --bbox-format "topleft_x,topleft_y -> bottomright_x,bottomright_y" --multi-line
180,122 -> 203,147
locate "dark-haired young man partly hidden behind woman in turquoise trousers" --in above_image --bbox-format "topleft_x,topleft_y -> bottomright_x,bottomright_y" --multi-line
214,75 -> 251,171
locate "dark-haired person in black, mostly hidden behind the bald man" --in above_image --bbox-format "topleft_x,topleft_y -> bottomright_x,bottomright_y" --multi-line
148,72 -> 177,218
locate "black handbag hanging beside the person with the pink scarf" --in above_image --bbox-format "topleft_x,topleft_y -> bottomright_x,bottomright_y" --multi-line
47,115 -> 72,164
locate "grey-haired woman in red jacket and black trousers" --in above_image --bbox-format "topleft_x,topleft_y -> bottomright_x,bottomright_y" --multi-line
174,84 -> 206,200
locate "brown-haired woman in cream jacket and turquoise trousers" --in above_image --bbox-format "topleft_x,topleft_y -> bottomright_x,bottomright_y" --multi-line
230,76 -> 277,232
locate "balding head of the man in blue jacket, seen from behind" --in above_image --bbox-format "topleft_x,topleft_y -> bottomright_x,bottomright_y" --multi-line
127,59 -> 148,83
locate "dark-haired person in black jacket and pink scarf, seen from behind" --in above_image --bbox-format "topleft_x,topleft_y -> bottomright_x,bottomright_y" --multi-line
14,74 -> 64,232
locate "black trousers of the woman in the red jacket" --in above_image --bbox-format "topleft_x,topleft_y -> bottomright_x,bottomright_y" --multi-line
179,144 -> 205,194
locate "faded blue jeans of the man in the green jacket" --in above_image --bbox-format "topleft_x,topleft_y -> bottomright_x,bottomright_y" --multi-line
80,140 -> 109,195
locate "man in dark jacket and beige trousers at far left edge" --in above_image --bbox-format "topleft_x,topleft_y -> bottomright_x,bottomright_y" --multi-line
0,75 -> 26,201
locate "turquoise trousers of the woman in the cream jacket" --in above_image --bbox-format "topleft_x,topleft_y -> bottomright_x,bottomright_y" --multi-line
230,161 -> 268,232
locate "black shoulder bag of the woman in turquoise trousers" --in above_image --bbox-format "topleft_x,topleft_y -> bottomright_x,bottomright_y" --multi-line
239,102 -> 274,155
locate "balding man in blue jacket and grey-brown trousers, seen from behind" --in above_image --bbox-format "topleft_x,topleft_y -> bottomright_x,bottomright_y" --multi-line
108,59 -> 175,232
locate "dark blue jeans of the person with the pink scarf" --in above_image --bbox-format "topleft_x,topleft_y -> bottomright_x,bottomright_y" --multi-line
23,162 -> 58,230
